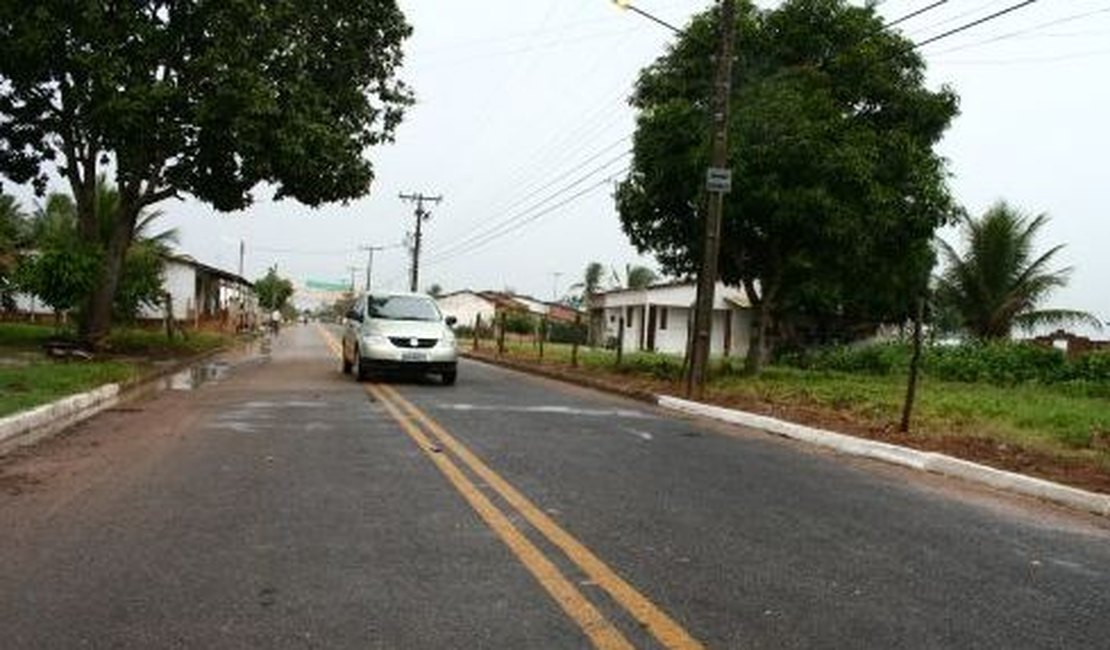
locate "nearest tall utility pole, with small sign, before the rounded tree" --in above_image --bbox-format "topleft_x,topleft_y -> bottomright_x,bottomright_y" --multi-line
686,0 -> 736,398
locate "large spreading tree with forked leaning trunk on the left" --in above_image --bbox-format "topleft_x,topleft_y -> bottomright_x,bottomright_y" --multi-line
0,0 -> 411,345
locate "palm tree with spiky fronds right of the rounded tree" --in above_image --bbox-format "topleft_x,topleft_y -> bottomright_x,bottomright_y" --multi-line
937,201 -> 1101,339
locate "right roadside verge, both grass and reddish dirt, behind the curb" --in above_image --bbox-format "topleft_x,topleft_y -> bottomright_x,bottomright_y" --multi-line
466,344 -> 1110,492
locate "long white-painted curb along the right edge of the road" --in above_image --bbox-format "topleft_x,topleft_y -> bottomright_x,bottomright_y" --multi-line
658,395 -> 1110,517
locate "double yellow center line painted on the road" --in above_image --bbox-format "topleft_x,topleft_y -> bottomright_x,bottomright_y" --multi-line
320,327 -> 703,650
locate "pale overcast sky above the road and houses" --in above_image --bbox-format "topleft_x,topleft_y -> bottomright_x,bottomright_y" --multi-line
4,0 -> 1110,319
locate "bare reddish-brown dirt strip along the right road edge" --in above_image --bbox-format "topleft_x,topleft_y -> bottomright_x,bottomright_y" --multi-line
467,352 -> 1110,494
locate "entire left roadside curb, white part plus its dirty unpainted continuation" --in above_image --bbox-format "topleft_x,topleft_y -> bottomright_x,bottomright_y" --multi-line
0,347 -> 226,457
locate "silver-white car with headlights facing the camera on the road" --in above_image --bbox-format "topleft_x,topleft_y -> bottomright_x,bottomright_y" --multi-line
343,292 -> 458,386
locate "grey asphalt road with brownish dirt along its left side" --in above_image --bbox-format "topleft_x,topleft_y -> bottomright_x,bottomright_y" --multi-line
0,326 -> 1110,649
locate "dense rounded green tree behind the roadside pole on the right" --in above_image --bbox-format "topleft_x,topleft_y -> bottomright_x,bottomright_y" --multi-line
617,0 -> 957,369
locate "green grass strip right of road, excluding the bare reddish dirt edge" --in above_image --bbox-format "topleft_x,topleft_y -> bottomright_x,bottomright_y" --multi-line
483,344 -> 1110,461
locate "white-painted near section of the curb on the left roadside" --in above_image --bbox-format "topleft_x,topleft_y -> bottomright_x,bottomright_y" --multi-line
0,384 -> 120,455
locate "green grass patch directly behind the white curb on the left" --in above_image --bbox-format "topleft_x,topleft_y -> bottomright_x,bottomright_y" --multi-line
0,360 -> 138,417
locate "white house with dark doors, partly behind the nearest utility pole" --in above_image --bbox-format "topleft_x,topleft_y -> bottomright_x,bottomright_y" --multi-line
591,282 -> 753,356
